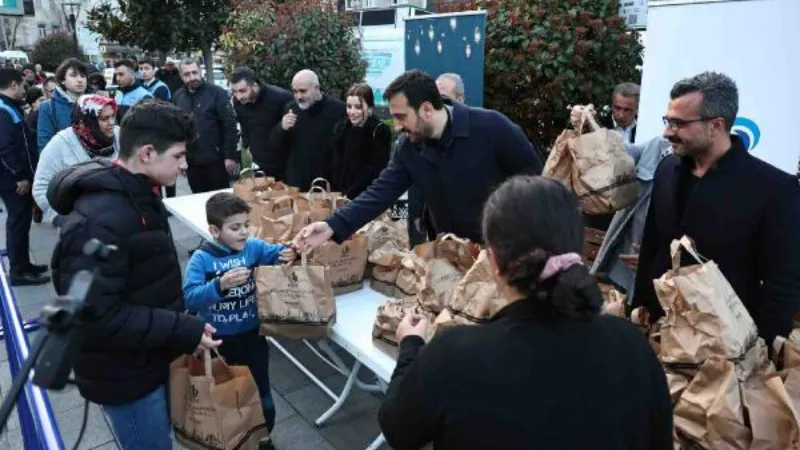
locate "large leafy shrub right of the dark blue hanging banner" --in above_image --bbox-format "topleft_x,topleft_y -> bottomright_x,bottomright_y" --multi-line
440,0 -> 642,151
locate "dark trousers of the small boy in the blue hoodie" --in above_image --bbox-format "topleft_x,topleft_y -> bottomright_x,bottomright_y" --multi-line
217,328 -> 275,433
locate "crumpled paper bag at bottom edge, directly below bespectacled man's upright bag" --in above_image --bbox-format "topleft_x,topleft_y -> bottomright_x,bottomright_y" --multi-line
674,358 -> 752,450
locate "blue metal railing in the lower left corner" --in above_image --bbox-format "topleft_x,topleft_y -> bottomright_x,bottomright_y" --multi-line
0,250 -> 64,450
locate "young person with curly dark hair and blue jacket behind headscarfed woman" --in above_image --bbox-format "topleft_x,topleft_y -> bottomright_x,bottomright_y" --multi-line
37,58 -> 88,152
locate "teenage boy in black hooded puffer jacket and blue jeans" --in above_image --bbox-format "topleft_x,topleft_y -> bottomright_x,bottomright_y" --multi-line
47,102 -> 220,450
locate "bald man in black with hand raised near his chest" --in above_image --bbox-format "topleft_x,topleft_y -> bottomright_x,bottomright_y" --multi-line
270,69 -> 347,191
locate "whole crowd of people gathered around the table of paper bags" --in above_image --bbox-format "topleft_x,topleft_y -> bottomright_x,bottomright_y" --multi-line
0,51 -> 800,450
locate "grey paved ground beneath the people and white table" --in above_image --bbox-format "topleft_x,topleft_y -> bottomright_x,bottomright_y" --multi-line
0,178 -> 388,450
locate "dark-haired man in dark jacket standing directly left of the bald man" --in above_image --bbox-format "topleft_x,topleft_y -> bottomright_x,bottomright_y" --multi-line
230,67 -> 293,179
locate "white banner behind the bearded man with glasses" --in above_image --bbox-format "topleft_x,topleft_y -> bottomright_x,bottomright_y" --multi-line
636,0 -> 800,174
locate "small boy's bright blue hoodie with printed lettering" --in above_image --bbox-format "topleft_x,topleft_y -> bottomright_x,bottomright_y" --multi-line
183,239 -> 284,336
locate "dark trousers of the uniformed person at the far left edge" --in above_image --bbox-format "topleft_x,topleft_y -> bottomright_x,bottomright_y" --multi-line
0,191 -> 33,274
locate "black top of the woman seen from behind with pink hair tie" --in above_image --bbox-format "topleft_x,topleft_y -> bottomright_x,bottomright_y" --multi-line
379,300 -> 672,450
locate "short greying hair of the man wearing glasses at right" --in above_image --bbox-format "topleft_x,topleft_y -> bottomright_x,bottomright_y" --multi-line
669,72 -> 739,131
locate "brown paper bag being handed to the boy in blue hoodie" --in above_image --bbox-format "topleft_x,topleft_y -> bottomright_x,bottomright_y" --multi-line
254,256 -> 336,339
